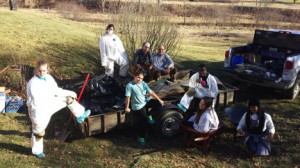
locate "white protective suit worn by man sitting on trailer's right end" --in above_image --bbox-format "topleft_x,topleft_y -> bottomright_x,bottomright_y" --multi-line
180,72 -> 219,109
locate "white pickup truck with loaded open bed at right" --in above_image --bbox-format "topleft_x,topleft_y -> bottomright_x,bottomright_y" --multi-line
221,30 -> 300,99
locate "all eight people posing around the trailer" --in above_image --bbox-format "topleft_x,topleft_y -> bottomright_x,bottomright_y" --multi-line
27,24 -> 275,158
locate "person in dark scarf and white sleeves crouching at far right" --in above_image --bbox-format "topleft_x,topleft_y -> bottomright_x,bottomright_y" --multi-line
237,98 -> 275,156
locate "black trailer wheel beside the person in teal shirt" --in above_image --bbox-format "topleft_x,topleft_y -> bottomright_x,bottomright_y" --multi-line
157,109 -> 183,138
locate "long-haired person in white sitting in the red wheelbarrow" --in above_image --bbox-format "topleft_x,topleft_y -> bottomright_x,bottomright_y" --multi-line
188,97 -> 219,133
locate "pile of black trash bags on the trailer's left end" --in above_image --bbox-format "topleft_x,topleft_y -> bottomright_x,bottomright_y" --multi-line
66,75 -> 126,115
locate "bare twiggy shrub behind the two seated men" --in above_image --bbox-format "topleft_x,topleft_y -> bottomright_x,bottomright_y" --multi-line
111,4 -> 179,61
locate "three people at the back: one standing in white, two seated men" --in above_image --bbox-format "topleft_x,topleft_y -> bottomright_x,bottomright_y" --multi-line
99,24 -> 176,81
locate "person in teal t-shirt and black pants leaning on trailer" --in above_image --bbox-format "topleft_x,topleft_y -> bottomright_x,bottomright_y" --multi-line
125,71 -> 164,145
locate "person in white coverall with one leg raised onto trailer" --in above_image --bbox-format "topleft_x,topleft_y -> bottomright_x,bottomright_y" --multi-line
27,60 -> 90,158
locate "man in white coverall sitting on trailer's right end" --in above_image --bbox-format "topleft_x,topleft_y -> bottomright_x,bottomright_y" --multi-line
177,64 -> 219,115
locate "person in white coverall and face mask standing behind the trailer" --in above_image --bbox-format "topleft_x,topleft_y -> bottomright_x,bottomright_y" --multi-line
99,24 -> 129,77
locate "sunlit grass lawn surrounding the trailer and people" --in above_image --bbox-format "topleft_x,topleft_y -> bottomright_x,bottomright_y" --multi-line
0,8 -> 300,167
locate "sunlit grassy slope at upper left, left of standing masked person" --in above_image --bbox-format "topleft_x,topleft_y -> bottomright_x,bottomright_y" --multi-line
0,9 -> 100,76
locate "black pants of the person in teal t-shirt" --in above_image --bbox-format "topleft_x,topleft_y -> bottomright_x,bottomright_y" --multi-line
133,99 -> 161,138
